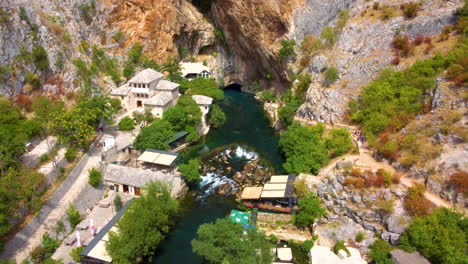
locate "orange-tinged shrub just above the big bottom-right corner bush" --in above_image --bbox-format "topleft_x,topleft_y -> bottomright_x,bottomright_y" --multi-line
404,184 -> 432,216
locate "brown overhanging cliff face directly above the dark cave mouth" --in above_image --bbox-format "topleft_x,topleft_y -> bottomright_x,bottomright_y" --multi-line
212,0 -> 293,87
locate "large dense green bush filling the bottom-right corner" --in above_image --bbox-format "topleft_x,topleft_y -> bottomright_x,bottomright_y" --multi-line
401,207 -> 468,264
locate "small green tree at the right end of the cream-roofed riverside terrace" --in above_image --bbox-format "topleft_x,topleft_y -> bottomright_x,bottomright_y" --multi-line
293,193 -> 327,228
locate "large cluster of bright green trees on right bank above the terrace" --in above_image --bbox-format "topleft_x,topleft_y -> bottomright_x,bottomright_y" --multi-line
280,123 -> 352,174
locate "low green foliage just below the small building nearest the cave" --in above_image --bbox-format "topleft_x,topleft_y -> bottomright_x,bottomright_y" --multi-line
181,78 -> 224,101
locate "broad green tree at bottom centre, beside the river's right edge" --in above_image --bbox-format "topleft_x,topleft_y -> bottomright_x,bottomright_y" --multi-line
192,218 -> 273,264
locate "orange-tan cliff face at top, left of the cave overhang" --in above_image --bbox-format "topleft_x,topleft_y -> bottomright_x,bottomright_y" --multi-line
108,0 -> 215,61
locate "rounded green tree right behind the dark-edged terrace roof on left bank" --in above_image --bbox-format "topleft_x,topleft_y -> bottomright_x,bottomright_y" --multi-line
133,119 -> 174,150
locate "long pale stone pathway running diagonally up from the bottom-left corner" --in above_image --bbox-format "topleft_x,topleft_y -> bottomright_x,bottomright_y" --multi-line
0,136 -> 103,263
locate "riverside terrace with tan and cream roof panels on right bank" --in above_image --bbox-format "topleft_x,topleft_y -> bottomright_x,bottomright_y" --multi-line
240,174 -> 297,213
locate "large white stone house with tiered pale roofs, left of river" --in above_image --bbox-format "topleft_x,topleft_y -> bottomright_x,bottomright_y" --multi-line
111,69 -> 179,118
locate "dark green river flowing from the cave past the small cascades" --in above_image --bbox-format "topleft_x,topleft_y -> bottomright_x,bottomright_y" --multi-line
153,86 -> 284,264
